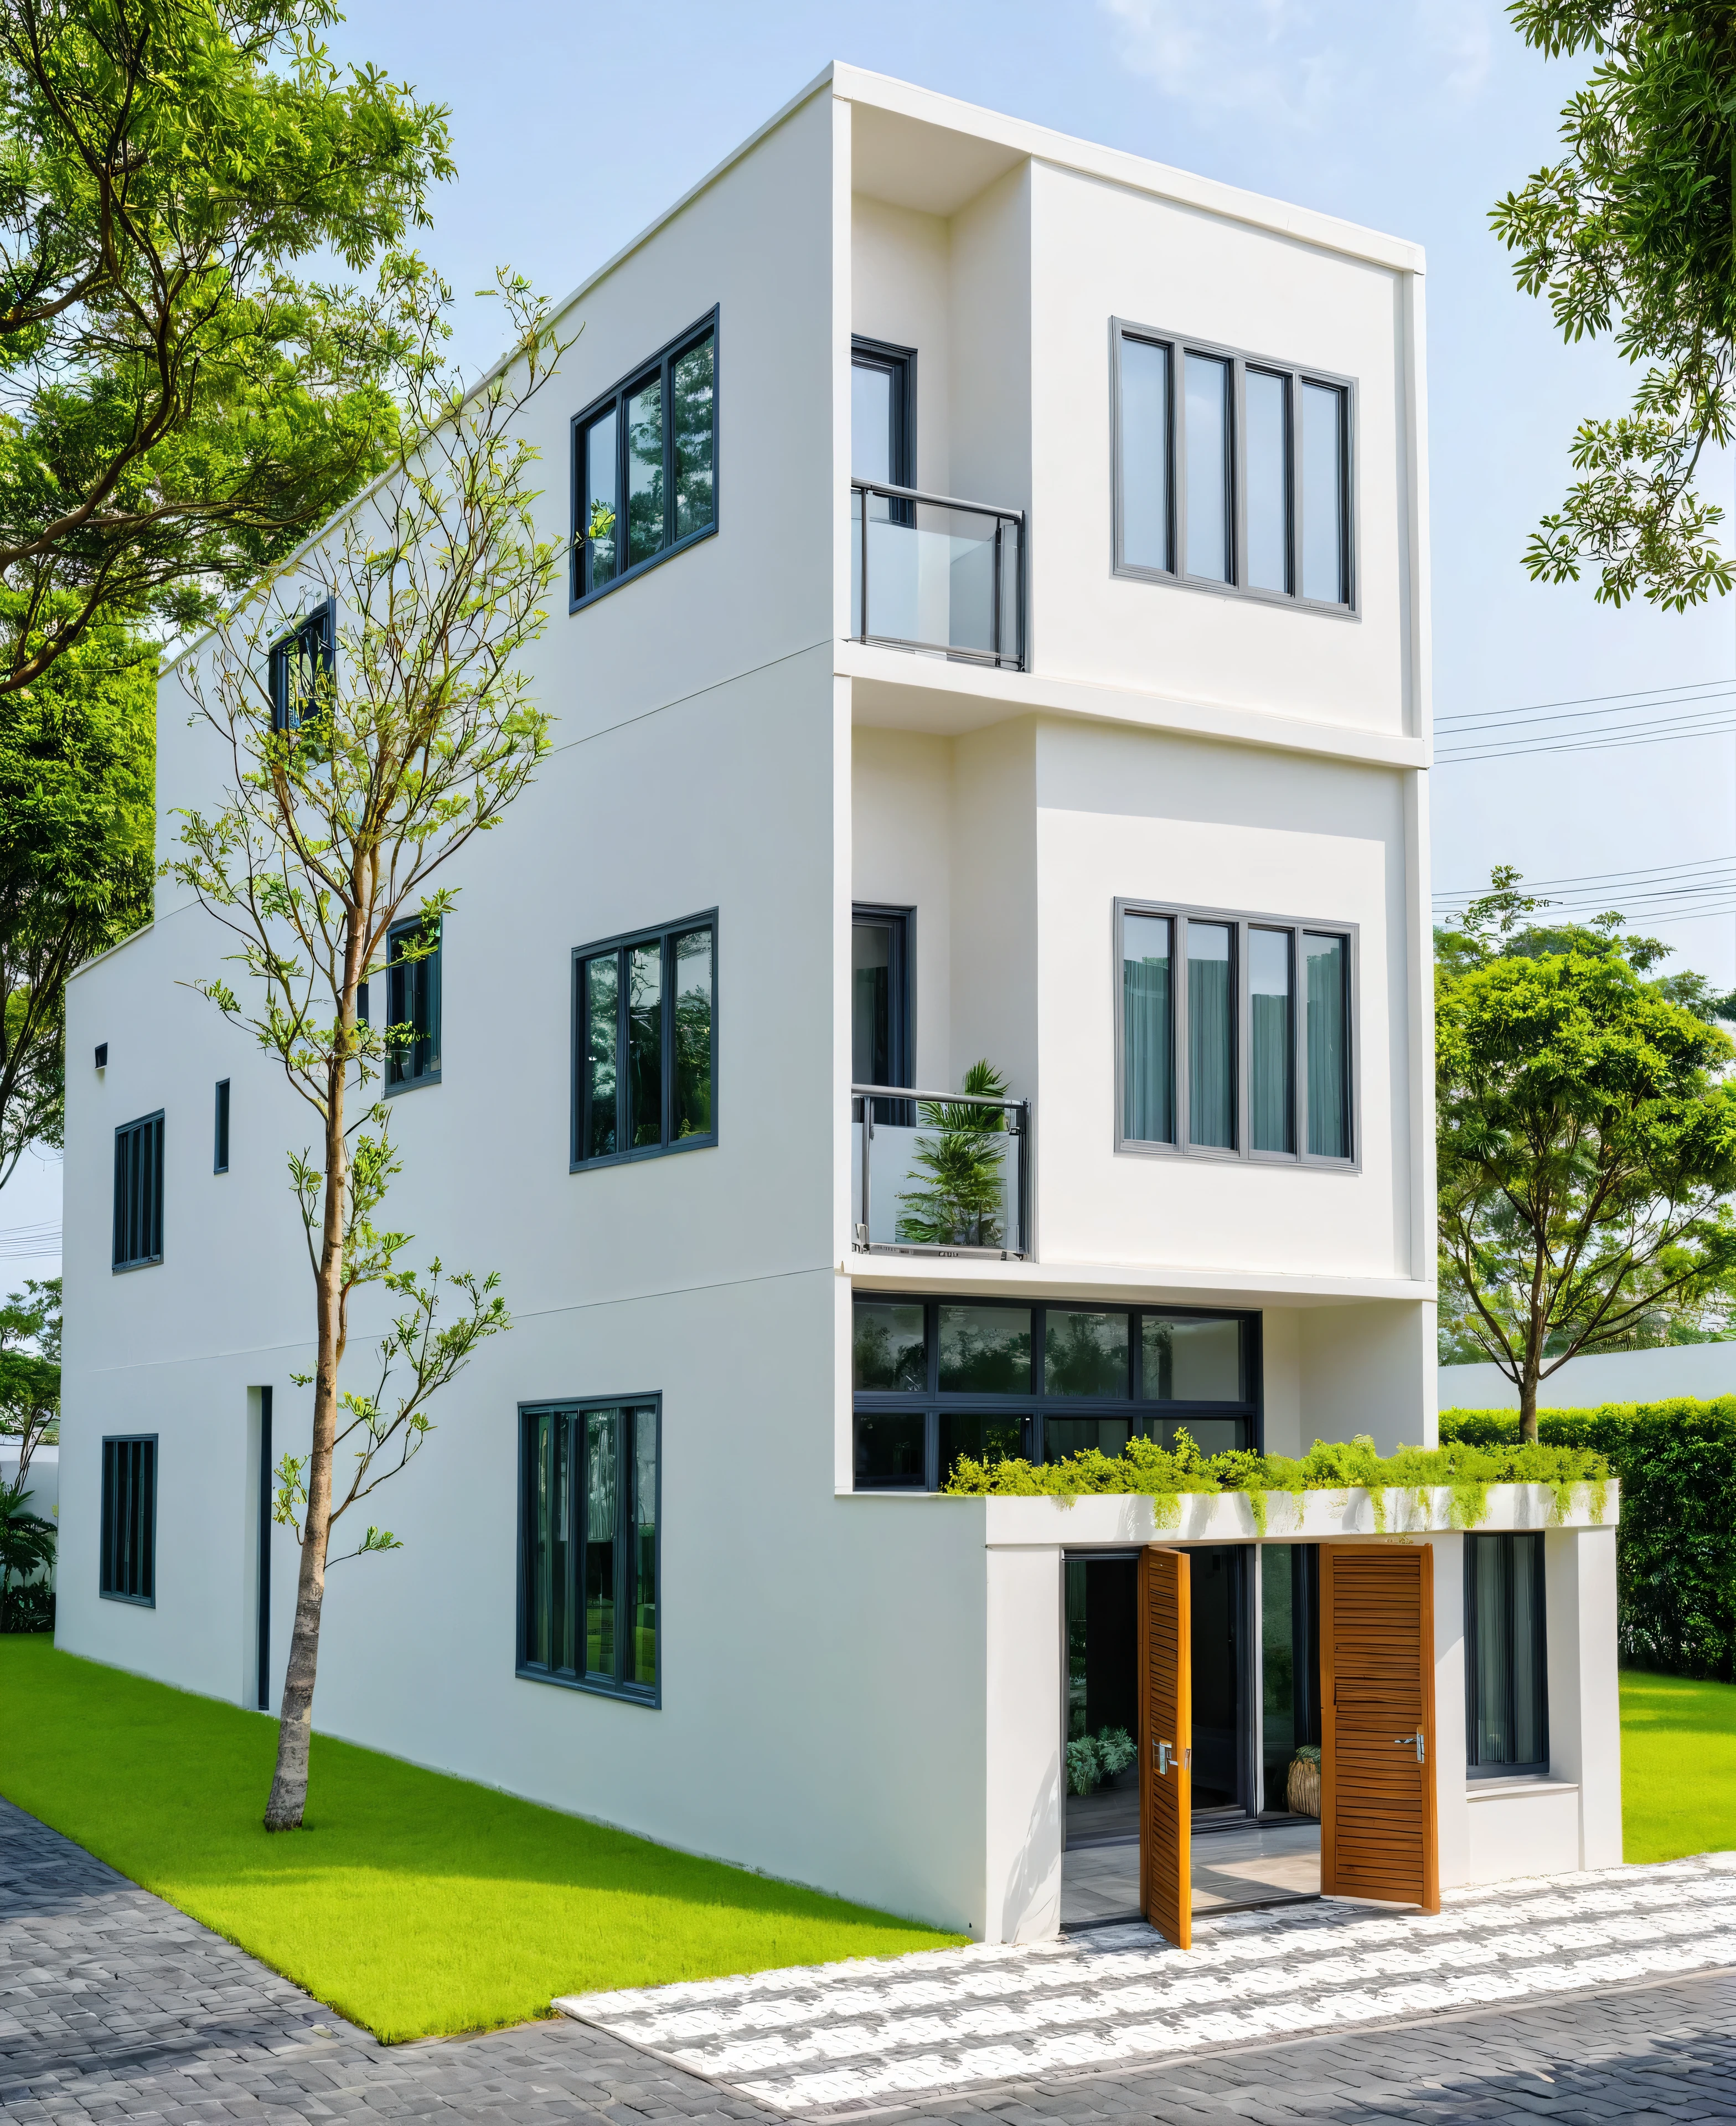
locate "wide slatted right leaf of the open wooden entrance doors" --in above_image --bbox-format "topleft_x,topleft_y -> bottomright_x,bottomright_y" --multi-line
1320,1544 -> 1440,1911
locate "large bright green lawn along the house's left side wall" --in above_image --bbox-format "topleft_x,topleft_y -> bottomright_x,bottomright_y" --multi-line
0,1635 -> 963,2041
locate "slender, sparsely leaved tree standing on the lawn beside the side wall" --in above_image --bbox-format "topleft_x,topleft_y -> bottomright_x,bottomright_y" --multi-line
170,261 -> 570,1830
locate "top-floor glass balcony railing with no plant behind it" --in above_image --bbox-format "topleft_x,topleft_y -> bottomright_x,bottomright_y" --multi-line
850,481 -> 1024,672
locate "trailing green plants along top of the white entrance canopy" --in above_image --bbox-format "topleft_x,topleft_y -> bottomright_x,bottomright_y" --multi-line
946,1428 -> 1611,1535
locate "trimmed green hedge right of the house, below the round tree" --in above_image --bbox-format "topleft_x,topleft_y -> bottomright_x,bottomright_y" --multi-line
1440,1395 -> 1736,1684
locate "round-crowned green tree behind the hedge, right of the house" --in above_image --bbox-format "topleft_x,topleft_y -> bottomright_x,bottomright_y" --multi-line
1434,871 -> 1736,1439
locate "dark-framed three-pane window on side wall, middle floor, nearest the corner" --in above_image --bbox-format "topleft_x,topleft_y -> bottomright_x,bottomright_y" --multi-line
572,910 -> 718,1169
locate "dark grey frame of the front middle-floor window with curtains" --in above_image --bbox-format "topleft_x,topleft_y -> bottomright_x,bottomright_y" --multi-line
1112,897 -> 1362,1174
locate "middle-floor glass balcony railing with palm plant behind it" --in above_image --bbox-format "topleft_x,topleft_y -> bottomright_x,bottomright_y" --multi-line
850,1084 -> 1032,1261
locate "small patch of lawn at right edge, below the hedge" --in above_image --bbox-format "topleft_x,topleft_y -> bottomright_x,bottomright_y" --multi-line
1621,1669 -> 1736,1860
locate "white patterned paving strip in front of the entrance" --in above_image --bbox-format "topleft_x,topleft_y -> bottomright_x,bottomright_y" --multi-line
555,1854 -> 1736,2111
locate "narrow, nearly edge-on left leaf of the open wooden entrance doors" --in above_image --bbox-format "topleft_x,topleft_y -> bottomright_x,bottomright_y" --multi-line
1139,1544 -> 1194,1949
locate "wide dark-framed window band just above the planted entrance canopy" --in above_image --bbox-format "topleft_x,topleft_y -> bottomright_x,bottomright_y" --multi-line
852,1293 -> 1262,1490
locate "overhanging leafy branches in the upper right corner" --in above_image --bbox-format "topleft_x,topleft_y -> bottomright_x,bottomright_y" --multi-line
1490,0 -> 1736,612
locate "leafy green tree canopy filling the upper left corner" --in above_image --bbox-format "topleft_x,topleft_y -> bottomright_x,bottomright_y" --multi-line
0,0 -> 453,695
